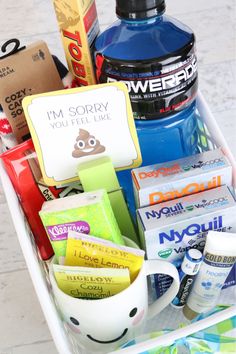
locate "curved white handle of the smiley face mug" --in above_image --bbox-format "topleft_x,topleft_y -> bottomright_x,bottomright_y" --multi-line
145,259 -> 180,319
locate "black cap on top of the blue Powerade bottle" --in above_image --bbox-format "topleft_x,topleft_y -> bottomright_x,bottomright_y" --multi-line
116,0 -> 166,19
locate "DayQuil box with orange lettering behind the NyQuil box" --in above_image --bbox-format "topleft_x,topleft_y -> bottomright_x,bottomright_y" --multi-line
132,149 -> 232,208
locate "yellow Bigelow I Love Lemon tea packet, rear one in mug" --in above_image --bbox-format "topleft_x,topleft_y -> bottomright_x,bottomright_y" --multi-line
65,231 -> 144,281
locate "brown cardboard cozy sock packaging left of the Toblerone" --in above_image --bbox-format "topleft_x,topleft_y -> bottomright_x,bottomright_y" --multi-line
0,41 -> 63,143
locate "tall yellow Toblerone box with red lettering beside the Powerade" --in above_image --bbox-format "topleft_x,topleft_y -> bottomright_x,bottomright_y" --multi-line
53,0 -> 99,86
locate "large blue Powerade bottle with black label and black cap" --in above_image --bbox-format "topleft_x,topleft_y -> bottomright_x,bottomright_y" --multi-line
95,0 -> 198,217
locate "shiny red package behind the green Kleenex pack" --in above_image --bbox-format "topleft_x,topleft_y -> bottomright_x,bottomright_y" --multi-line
0,139 -> 82,260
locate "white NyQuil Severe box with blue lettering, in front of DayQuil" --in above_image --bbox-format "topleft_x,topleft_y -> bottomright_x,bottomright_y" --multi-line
137,186 -> 236,264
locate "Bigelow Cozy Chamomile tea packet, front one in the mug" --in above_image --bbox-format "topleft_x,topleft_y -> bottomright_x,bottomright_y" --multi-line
53,264 -> 130,299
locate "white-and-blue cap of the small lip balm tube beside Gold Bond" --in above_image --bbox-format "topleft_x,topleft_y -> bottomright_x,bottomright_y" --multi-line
181,248 -> 203,275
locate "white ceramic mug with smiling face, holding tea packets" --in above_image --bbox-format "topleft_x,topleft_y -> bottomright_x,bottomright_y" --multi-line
49,260 -> 179,353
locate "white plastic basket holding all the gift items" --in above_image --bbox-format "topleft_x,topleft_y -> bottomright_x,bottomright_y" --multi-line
0,94 -> 236,354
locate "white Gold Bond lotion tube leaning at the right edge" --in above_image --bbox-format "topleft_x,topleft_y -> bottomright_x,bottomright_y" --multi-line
183,231 -> 236,320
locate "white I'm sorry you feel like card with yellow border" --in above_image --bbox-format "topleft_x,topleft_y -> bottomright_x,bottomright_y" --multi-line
23,83 -> 142,185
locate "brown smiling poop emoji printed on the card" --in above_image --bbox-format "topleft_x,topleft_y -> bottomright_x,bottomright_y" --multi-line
72,129 -> 106,158
